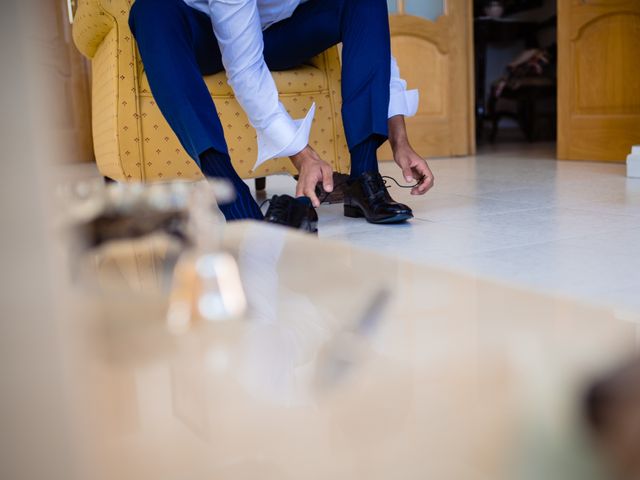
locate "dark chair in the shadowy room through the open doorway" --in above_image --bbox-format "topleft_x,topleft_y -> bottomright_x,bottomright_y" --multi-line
487,45 -> 558,142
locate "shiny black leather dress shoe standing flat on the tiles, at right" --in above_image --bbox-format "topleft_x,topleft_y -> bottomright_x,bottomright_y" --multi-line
344,172 -> 413,223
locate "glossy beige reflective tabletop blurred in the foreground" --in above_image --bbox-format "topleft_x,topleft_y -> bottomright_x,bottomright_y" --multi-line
70,220 -> 637,480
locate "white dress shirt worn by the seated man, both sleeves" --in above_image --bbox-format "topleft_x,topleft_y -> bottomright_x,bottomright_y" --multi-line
184,0 -> 418,169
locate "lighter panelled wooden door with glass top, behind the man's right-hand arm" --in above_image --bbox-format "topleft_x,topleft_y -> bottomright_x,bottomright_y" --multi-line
379,0 -> 475,159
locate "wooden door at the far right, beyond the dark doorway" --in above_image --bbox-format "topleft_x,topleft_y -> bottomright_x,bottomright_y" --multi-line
558,0 -> 640,162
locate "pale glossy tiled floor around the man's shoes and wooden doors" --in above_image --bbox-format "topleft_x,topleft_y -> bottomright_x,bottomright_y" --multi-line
250,144 -> 640,310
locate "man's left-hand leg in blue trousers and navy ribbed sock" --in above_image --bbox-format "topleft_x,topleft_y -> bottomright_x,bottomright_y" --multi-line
129,0 -> 262,220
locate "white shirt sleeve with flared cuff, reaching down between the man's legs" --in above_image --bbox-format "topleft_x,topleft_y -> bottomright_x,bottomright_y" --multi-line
208,0 -> 315,169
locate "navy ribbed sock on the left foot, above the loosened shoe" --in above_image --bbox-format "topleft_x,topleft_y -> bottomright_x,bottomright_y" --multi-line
200,149 -> 264,221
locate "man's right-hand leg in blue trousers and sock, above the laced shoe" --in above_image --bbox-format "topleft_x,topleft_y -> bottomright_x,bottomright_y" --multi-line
264,0 -> 391,176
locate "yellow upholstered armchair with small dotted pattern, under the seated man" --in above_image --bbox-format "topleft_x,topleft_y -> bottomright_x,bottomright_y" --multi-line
73,0 -> 349,181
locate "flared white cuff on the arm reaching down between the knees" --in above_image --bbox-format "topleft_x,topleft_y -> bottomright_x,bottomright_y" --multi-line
253,103 -> 316,170
